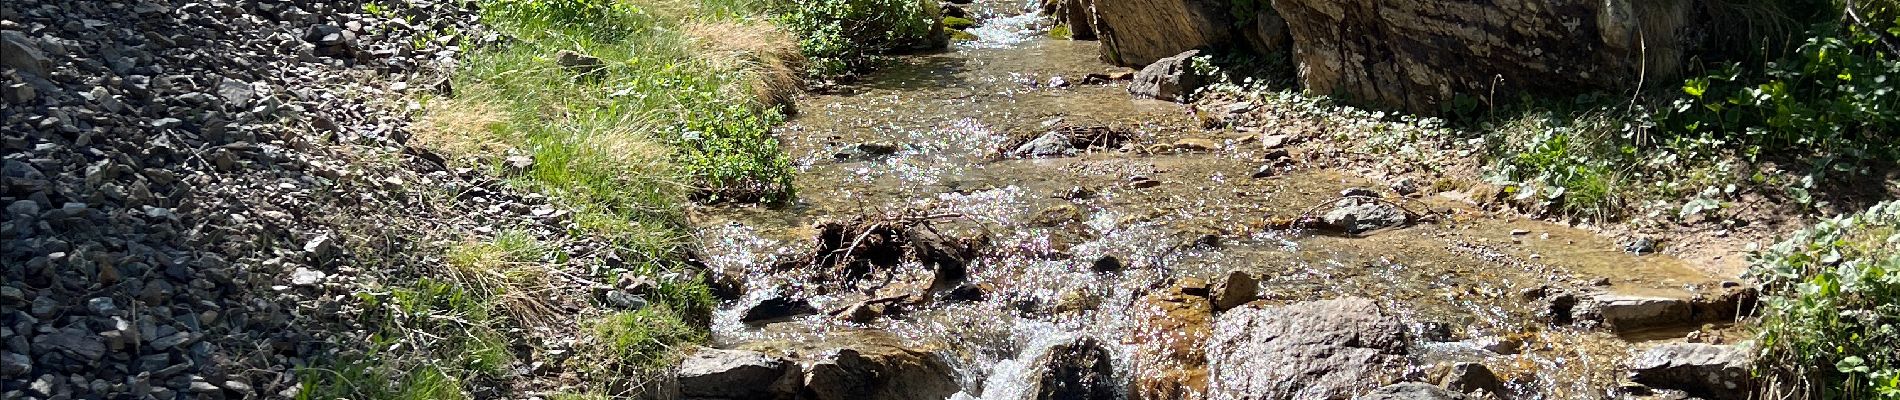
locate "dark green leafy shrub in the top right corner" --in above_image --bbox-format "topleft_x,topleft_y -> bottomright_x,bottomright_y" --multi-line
1657,0 -> 1900,171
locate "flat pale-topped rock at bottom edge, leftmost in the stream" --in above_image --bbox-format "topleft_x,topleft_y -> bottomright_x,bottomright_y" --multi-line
678,349 -> 804,400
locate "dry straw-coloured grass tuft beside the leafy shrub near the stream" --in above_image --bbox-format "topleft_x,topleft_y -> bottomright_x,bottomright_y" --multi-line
686,21 -> 806,112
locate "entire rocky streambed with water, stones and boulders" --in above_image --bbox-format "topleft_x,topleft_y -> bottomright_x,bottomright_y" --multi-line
678,2 -> 1754,398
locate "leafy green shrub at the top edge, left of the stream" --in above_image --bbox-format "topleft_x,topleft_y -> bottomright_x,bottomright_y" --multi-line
775,0 -> 948,76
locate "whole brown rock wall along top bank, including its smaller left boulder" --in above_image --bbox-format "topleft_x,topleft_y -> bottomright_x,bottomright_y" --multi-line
1064,0 -> 1706,114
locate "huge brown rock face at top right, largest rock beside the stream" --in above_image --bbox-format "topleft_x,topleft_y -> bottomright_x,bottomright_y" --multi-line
1276,0 -> 1697,114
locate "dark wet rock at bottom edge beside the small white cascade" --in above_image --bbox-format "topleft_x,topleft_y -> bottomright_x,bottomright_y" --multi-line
1036,337 -> 1121,400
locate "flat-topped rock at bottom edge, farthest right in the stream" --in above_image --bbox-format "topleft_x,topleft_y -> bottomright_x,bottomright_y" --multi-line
1630,343 -> 1756,400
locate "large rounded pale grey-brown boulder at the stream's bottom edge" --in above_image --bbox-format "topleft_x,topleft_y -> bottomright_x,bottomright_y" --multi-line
1207,298 -> 1406,400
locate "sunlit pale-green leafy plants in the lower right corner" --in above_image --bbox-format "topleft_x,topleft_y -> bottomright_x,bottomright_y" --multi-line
1750,203 -> 1900,398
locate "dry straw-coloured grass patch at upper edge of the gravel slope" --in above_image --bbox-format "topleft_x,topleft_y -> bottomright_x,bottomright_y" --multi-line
410,97 -> 513,161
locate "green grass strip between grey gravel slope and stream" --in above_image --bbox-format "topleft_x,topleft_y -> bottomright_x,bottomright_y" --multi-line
300,0 -> 820,400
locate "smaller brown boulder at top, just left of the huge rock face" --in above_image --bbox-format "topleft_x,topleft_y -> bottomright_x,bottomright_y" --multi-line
1094,0 -> 1235,66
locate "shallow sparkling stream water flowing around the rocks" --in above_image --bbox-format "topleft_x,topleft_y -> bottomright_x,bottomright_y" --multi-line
694,4 -> 1740,400
